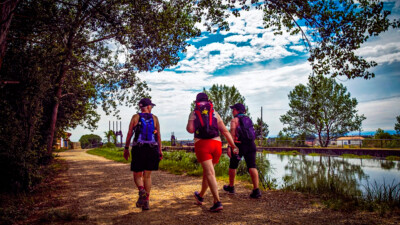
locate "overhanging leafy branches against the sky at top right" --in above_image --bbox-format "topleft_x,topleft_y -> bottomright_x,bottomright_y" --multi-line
228,0 -> 400,79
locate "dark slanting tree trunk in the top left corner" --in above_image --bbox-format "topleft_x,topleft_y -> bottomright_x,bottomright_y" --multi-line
0,0 -> 20,69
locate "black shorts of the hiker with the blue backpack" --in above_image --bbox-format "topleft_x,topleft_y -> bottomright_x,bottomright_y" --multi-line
131,144 -> 160,172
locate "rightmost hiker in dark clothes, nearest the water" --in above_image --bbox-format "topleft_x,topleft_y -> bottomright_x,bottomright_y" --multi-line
224,103 -> 261,198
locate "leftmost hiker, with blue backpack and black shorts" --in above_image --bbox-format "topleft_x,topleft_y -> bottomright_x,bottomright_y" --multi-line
124,98 -> 163,210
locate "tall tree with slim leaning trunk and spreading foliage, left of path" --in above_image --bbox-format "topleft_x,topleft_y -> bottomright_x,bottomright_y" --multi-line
5,0 -> 228,153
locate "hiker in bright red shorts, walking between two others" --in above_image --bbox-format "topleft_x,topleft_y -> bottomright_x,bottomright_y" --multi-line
186,93 -> 239,212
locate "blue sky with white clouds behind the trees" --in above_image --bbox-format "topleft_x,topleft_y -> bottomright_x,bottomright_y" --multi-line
69,0 -> 400,142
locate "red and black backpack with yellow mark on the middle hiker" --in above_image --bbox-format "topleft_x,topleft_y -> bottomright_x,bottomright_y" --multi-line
194,101 -> 219,139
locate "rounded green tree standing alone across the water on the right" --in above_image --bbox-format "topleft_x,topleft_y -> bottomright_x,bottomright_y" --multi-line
280,76 -> 365,147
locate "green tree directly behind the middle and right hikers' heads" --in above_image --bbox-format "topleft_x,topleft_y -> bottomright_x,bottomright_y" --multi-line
203,84 -> 248,126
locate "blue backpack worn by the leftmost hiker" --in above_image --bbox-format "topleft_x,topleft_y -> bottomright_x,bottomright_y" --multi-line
134,113 -> 158,144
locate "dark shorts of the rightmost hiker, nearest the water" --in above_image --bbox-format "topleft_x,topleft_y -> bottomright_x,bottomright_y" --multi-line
229,141 -> 257,169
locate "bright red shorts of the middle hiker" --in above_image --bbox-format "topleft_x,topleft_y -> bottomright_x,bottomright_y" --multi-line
194,139 -> 222,164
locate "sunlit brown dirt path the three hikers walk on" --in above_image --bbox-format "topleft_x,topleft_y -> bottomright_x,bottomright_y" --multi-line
51,150 -> 400,224
